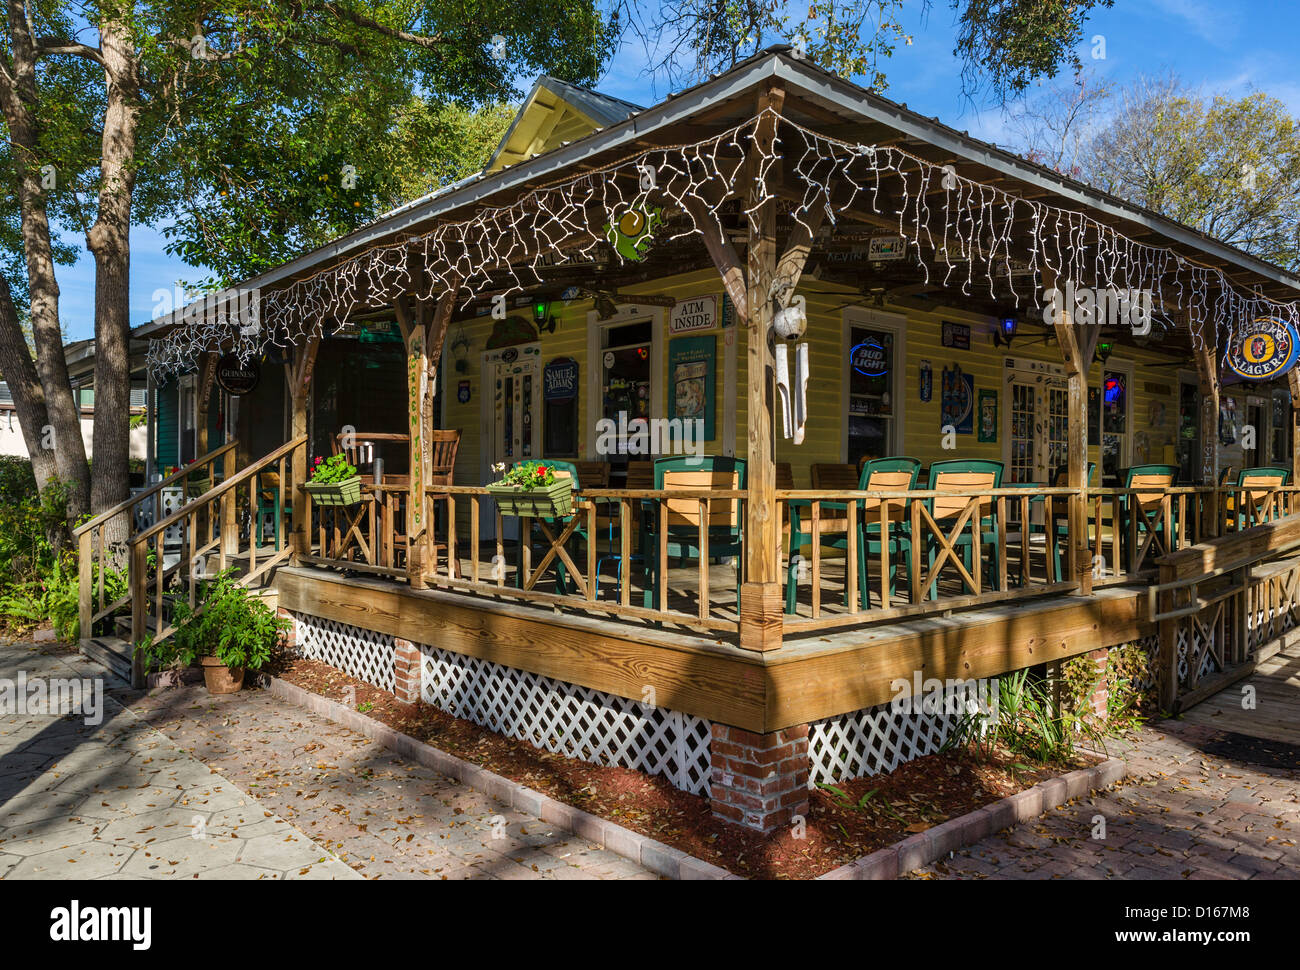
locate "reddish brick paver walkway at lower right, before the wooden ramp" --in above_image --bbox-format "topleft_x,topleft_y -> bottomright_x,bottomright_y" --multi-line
913,670 -> 1300,879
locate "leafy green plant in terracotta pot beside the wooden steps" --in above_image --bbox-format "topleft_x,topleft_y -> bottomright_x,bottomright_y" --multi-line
137,570 -> 289,694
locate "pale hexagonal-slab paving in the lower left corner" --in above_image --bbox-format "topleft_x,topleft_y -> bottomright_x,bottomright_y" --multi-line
0,645 -> 358,879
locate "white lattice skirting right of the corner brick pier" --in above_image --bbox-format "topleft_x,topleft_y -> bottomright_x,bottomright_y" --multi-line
809,680 -> 997,783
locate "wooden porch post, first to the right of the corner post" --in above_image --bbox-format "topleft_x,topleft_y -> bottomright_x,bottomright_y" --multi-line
1043,261 -> 1097,596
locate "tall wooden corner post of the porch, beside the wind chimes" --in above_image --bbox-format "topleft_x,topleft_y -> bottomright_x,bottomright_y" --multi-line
740,86 -> 784,650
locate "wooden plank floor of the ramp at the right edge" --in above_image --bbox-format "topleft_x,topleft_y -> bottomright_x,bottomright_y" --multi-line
1183,636 -> 1300,745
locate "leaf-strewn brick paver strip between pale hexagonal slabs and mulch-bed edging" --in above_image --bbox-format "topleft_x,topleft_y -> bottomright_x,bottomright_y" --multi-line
122,670 -> 658,879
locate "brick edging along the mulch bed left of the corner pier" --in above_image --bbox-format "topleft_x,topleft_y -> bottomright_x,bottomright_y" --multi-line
257,674 -> 741,879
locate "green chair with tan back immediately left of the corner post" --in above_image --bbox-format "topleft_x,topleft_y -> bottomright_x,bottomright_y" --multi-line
641,455 -> 745,610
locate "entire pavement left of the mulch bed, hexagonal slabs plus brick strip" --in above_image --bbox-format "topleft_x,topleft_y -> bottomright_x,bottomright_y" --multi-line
0,645 -> 655,879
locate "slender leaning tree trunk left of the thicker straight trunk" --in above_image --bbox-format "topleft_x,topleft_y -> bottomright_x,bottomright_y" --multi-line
0,0 -> 90,518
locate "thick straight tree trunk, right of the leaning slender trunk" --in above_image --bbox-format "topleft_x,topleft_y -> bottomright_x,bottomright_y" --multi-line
86,18 -> 139,541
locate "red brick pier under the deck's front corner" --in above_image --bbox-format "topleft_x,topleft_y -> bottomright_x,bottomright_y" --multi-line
710,723 -> 809,832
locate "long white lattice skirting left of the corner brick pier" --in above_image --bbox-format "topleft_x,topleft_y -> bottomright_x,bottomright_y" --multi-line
420,645 -> 711,794
